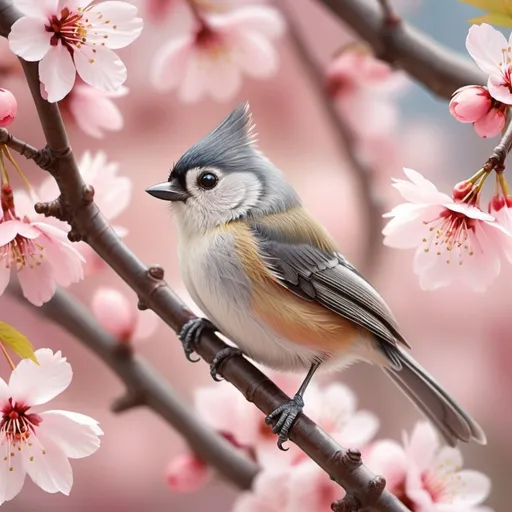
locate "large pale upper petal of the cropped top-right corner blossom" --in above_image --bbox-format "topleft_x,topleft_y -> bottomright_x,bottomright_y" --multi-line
466,23 -> 508,75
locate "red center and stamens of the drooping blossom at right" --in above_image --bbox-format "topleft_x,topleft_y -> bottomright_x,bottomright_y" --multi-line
422,208 -> 476,265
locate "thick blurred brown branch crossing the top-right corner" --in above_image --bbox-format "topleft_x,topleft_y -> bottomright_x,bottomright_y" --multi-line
318,0 -> 487,98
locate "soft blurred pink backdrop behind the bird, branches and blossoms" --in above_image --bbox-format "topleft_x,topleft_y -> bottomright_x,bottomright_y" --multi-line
0,0 -> 512,512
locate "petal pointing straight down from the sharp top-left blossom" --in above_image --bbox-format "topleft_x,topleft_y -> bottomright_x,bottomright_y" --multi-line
39,44 -> 76,103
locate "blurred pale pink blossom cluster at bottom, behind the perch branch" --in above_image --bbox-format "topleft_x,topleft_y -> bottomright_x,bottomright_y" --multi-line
166,374 -> 490,512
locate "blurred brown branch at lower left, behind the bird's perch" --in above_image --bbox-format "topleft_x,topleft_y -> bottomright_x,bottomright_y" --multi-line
9,284 -> 259,489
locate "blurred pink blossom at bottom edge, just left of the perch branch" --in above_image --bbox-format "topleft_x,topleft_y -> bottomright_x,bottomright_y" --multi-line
233,459 -> 344,512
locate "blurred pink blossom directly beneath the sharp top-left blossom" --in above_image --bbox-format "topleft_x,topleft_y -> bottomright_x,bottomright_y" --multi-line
59,84 -> 129,139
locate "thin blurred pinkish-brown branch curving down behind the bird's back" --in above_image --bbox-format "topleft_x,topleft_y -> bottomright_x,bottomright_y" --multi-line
280,0 -> 384,274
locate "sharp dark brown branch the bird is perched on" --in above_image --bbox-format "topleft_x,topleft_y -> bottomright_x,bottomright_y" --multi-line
0,0 -> 407,512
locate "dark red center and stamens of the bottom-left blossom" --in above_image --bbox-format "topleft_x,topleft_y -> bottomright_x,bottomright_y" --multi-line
0,398 -> 46,471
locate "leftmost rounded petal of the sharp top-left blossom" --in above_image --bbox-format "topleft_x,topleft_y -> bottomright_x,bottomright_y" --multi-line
9,17 -> 52,62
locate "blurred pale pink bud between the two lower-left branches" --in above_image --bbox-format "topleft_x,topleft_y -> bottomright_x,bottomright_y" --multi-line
91,288 -> 137,341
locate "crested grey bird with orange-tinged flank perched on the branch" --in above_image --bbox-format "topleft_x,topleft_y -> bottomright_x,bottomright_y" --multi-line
146,102 -> 486,449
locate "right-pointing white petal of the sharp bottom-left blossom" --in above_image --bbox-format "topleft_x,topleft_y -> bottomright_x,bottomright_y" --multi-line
38,411 -> 103,459
